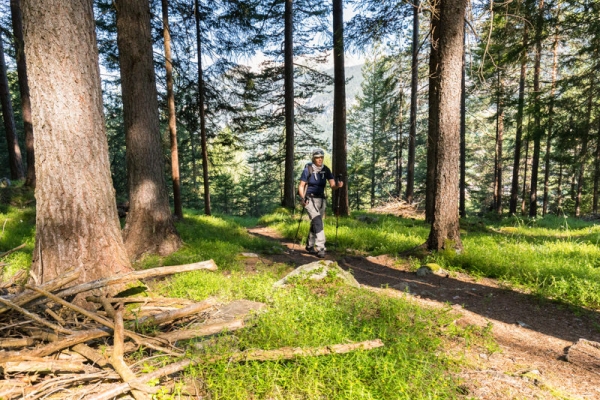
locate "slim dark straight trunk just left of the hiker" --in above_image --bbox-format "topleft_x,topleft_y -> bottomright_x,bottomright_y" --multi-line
282,0 -> 295,208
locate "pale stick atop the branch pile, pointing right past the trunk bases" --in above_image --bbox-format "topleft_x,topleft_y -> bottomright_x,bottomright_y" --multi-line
57,260 -> 217,297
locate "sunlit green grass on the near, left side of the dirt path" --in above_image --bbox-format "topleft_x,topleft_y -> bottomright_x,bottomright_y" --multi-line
0,200 -> 472,399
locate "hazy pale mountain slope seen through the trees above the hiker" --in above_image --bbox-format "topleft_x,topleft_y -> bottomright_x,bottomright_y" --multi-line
309,64 -> 363,145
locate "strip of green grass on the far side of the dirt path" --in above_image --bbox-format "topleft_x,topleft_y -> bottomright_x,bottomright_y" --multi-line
260,213 -> 600,309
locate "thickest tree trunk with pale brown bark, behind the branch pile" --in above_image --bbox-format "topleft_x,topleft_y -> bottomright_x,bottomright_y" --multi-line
22,0 -> 131,283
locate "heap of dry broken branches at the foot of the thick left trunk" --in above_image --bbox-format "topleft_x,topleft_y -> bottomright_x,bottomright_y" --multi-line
0,260 -> 383,400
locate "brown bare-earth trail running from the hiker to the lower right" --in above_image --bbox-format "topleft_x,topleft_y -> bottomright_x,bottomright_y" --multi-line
249,227 -> 600,399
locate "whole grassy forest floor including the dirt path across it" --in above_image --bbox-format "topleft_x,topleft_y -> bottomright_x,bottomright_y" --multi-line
0,189 -> 600,399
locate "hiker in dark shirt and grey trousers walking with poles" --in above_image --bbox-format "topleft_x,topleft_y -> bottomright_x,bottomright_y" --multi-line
298,149 -> 344,258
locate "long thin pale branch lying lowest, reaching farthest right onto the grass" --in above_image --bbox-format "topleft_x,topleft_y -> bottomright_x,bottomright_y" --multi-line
87,339 -> 383,400
